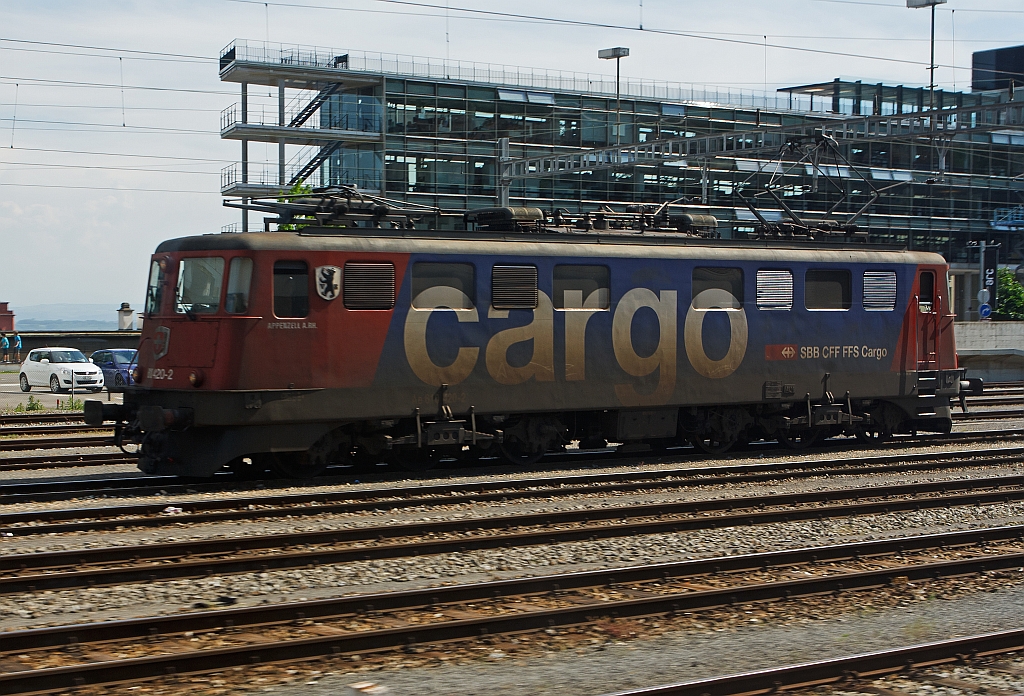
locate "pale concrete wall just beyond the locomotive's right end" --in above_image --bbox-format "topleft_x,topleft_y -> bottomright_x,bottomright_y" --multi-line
953,321 -> 1024,382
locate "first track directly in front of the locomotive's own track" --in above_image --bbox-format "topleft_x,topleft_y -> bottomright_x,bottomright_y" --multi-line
0,447 -> 1024,535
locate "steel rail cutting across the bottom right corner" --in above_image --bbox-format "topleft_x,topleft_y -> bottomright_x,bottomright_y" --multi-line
605,628 -> 1024,696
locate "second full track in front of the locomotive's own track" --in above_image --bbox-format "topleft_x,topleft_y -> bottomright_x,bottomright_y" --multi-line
6,476 -> 1024,594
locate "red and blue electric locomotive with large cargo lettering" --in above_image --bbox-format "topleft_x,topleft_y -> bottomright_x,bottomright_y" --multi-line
85,189 -> 980,477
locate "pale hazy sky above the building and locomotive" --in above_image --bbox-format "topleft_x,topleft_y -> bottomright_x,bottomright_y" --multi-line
0,0 -> 1024,319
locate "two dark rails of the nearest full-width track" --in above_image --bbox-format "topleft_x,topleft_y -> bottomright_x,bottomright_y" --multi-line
0,528 -> 1024,694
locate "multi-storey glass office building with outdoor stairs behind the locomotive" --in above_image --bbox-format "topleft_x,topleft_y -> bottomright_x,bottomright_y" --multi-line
220,40 -> 1024,312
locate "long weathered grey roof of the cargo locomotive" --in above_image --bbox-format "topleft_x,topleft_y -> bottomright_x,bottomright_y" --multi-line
157,232 -> 945,264
